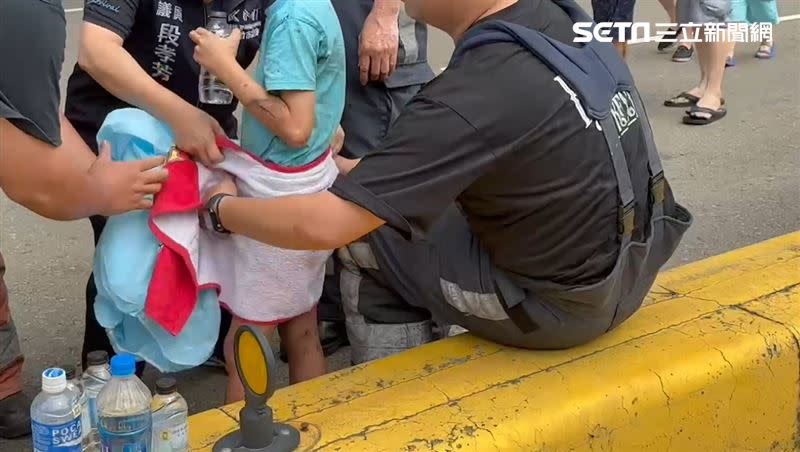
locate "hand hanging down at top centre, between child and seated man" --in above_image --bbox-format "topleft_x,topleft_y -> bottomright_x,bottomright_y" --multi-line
358,11 -> 400,85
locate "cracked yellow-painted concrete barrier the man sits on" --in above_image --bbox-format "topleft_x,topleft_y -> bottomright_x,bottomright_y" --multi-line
183,234 -> 800,451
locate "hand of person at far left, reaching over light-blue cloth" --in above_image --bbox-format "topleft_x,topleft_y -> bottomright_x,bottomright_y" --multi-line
89,142 -> 169,216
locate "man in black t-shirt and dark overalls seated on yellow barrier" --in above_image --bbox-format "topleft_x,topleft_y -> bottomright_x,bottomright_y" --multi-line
197,0 -> 691,363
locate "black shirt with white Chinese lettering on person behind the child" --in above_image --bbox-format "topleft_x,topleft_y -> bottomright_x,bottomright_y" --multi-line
66,0 -> 271,149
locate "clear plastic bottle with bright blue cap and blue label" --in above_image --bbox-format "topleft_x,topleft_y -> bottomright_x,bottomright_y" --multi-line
97,353 -> 153,452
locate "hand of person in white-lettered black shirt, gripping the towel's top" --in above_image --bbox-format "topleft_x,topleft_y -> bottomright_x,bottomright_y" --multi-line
167,104 -> 225,167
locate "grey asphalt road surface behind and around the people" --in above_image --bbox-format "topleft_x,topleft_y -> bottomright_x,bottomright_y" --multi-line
0,0 -> 800,451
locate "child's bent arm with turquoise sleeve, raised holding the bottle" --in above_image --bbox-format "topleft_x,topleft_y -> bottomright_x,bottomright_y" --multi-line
190,24 -> 318,148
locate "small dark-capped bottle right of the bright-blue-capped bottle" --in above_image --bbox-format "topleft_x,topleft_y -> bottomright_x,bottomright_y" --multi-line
151,377 -> 189,452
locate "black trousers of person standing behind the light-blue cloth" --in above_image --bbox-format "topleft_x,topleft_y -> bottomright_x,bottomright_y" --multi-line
81,216 -> 231,375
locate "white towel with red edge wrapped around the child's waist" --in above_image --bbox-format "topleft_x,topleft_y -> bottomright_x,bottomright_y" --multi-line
146,139 -> 338,334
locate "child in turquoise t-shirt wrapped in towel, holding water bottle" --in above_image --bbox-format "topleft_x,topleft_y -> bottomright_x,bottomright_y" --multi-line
190,0 -> 345,402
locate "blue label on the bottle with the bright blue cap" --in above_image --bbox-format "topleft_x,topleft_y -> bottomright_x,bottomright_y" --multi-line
98,411 -> 153,452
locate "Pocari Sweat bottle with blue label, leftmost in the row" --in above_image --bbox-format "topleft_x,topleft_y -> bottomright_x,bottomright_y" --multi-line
31,368 -> 83,452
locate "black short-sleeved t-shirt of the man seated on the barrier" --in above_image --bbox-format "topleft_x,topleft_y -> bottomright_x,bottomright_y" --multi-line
331,0 -> 648,285
